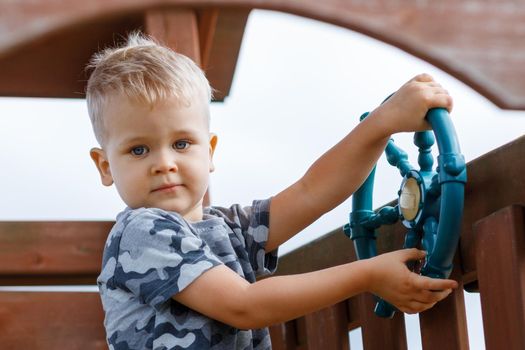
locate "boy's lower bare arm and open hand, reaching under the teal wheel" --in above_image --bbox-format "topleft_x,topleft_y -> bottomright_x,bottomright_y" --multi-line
174,249 -> 457,329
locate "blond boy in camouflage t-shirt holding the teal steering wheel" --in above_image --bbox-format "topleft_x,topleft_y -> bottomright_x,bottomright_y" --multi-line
87,34 -> 457,349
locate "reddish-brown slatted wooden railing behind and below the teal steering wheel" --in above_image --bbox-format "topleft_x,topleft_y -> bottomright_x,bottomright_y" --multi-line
271,137 -> 525,350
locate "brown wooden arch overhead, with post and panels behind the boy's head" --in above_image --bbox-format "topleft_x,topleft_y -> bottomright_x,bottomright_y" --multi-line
0,0 -> 525,109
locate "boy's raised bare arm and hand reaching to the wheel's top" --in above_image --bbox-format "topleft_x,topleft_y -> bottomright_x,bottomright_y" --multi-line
265,74 -> 452,252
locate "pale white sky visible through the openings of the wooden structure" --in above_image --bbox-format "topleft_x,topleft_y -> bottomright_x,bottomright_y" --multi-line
0,11 -> 525,349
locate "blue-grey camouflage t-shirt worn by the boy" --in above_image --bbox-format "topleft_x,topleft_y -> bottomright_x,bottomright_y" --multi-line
97,200 -> 277,350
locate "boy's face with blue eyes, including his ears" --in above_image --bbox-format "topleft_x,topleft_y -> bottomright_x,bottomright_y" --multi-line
91,98 -> 217,221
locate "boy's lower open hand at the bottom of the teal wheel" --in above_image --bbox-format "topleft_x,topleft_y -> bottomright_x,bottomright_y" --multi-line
368,249 -> 458,314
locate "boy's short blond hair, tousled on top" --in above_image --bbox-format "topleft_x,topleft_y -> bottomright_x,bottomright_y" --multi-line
86,32 -> 212,146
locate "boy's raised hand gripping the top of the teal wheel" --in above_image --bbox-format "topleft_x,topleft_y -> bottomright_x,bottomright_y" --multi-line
370,74 -> 453,136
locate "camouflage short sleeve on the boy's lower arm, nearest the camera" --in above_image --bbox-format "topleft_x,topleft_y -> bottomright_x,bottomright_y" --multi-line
113,209 -> 221,308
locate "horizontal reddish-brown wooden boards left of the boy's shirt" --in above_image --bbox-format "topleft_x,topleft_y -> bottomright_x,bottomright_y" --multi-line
0,222 -> 109,350
